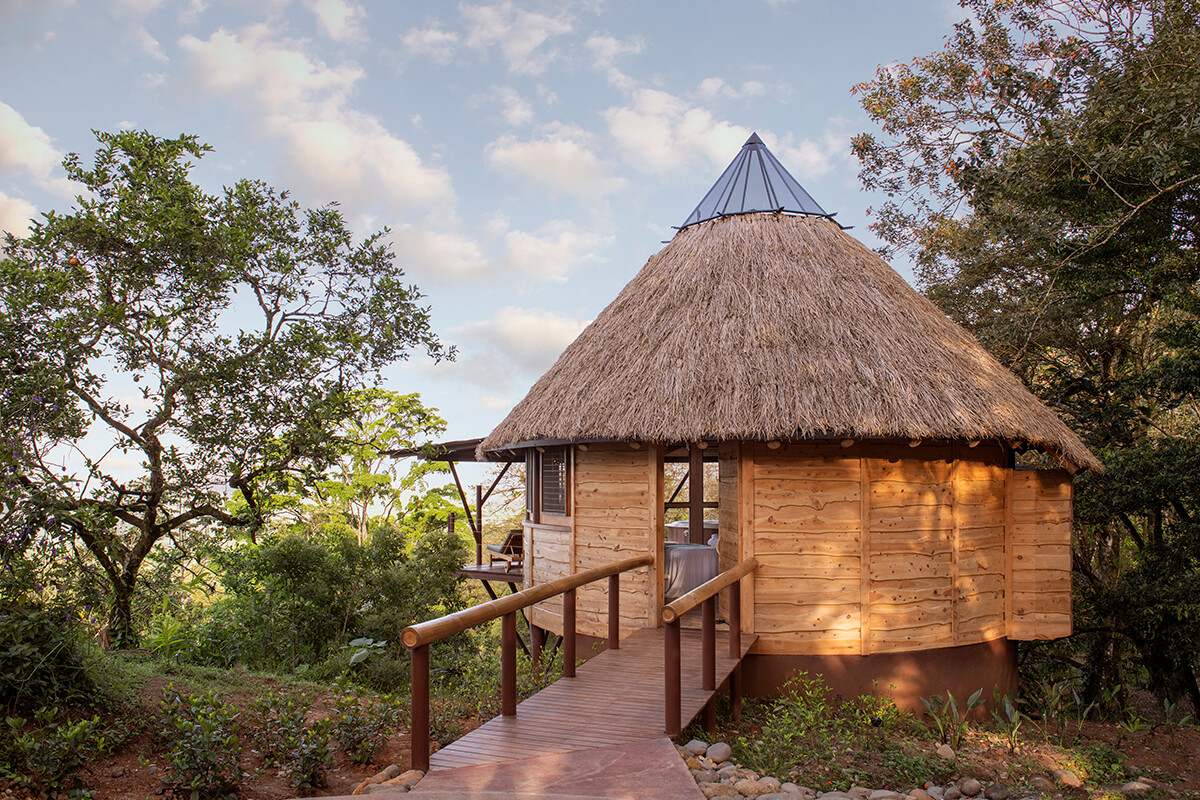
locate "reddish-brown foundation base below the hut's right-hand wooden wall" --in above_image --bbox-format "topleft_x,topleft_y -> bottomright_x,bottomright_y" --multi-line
742,639 -> 1016,714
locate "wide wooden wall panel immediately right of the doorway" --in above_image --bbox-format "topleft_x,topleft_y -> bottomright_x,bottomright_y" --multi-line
743,444 -> 863,654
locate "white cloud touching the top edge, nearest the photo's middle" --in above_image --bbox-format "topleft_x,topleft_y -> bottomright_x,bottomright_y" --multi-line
460,1 -> 571,74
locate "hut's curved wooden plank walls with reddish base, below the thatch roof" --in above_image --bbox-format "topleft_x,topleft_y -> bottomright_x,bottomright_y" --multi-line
526,440 -> 1072,706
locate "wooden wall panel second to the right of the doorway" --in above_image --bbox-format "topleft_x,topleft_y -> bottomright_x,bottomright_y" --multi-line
865,445 -> 955,654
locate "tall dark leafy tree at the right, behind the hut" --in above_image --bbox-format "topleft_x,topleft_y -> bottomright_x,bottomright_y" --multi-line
853,0 -> 1200,706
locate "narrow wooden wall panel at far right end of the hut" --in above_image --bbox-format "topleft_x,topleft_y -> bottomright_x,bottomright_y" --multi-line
1009,469 -> 1072,640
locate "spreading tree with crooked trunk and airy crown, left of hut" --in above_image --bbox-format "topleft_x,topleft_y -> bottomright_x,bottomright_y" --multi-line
0,132 -> 452,637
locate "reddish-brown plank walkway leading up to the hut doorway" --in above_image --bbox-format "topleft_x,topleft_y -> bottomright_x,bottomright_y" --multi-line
430,628 -> 756,771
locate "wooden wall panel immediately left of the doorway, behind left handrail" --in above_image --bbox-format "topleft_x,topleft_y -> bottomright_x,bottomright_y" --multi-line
572,444 -> 661,638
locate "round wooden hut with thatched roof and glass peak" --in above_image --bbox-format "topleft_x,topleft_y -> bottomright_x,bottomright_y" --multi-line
479,136 -> 1103,705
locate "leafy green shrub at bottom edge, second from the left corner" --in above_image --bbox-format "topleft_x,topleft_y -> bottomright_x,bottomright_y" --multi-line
161,686 -> 241,800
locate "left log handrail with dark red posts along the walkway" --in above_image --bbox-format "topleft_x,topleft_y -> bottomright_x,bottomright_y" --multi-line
400,553 -> 654,771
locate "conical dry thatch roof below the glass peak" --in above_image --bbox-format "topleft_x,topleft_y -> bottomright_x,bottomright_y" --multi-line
480,213 -> 1103,470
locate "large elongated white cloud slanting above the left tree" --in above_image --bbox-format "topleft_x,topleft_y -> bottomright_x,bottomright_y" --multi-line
180,25 -> 454,211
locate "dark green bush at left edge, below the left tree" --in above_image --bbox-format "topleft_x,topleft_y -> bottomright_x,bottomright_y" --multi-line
0,601 -> 95,710
